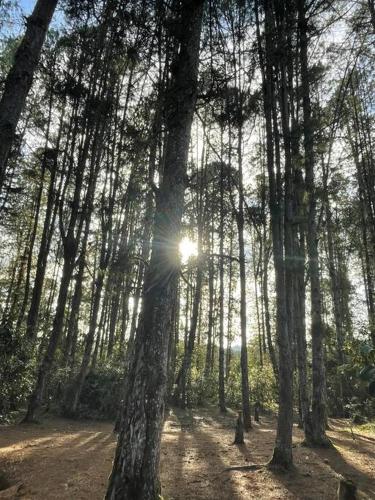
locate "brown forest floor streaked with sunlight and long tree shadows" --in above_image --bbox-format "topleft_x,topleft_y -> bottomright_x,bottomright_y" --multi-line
0,407 -> 375,500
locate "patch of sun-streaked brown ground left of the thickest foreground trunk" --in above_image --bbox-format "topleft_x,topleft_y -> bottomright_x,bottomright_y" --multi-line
0,419 -> 115,499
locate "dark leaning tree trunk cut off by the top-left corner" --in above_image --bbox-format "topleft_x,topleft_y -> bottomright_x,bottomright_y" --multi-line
0,0 -> 58,189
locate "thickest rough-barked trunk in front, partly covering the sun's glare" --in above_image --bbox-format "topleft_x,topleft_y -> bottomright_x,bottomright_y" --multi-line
106,0 -> 204,500
